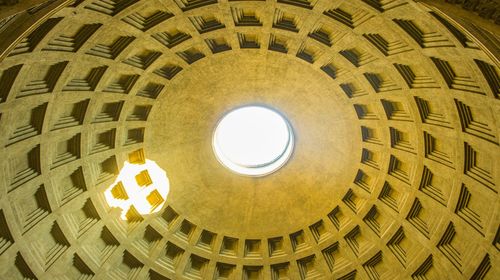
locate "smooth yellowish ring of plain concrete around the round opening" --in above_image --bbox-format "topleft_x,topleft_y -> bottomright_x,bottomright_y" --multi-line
144,52 -> 361,238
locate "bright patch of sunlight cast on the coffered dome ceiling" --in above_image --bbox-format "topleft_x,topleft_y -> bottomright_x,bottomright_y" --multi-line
104,159 -> 170,220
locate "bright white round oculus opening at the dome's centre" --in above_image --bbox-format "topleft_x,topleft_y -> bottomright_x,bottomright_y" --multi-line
212,105 -> 294,176
